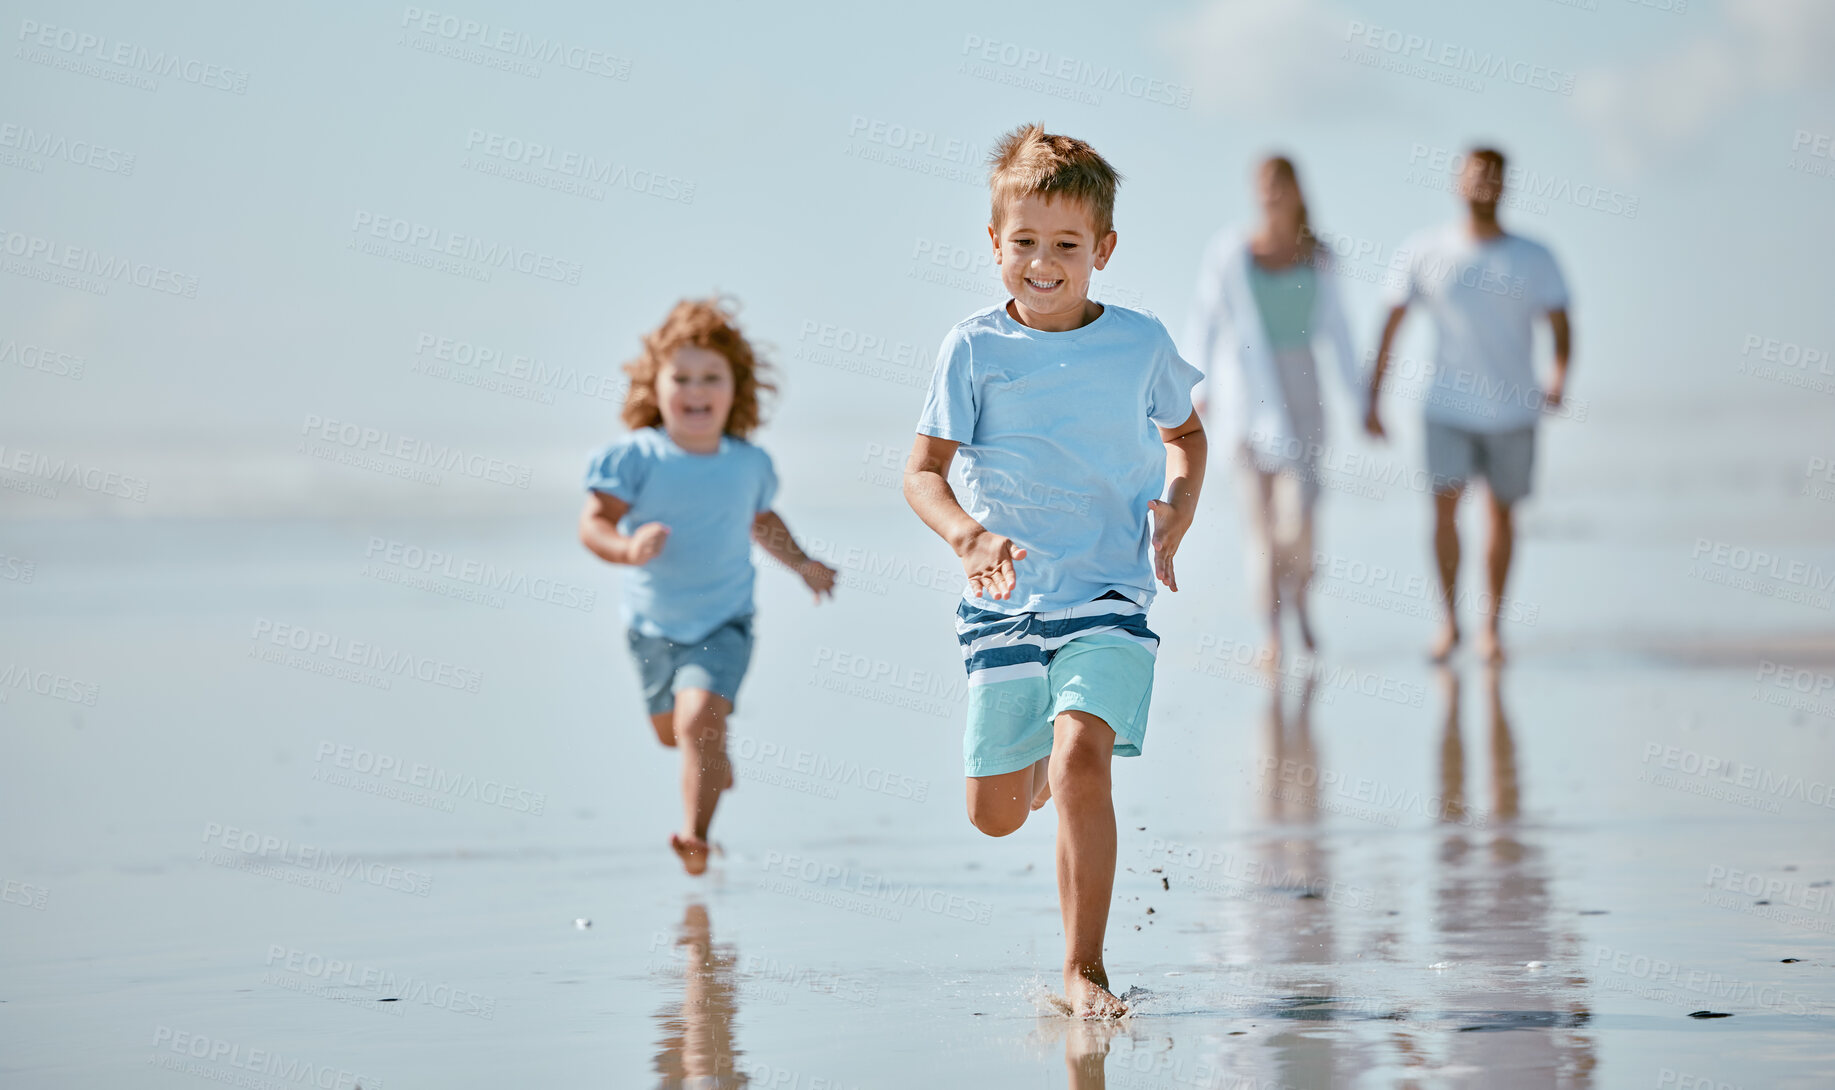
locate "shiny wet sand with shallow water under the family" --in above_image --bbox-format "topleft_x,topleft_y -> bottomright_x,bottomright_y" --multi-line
0,477 -> 1835,1090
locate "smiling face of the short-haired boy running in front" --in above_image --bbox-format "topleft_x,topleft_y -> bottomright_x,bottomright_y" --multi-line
987,195 -> 1116,332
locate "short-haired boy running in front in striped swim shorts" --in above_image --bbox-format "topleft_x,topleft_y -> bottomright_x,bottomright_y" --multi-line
905,125 -> 1204,1017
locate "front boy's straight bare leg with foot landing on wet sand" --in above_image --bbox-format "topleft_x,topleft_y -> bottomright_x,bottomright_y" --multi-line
1051,712 -> 1127,1018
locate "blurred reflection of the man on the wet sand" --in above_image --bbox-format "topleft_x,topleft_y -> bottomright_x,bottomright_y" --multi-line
1431,666 -> 1596,1088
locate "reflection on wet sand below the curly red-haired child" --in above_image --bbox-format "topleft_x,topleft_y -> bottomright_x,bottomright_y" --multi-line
655,903 -> 751,1090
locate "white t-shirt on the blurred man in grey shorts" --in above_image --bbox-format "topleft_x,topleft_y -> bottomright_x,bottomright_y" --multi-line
1389,222 -> 1567,431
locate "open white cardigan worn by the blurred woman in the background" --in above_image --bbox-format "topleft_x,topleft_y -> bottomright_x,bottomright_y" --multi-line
1185,228 -> 1369,462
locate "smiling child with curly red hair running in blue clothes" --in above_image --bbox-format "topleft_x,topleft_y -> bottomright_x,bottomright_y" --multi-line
580,299 -> 835,873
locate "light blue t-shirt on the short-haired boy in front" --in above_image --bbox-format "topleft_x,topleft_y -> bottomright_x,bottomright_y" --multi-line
918,303 -> 1202,613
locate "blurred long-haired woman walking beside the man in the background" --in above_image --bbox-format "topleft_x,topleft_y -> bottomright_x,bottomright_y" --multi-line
1185,156 -> 1367,664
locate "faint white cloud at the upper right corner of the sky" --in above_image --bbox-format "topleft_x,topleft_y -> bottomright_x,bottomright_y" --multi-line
1574,0 -> 1835,172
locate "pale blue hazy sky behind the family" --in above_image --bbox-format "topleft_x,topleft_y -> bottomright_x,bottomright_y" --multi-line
0,0 -> 1835,517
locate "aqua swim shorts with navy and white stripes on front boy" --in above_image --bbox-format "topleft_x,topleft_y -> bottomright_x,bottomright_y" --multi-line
956,591 -> 1160,776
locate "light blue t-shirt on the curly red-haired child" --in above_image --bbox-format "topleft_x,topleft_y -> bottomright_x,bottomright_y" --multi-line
585,428 -> 778,644
